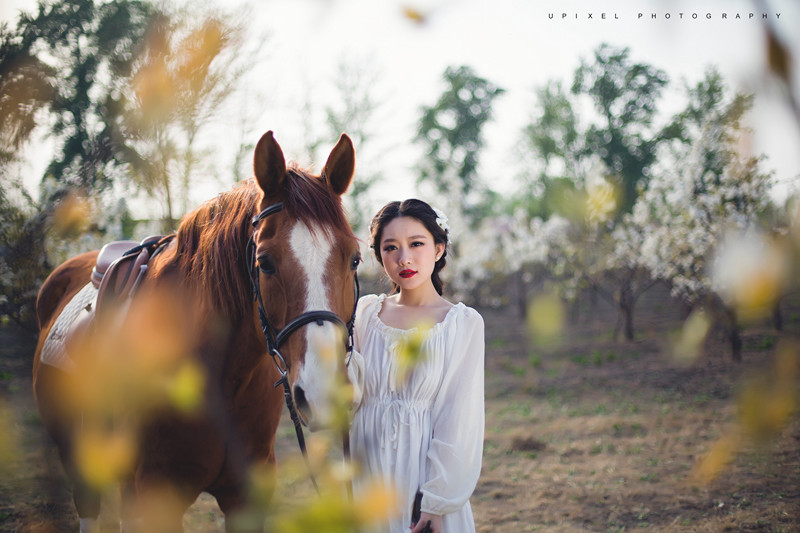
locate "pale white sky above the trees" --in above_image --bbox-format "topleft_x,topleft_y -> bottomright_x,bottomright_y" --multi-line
0,0 -> 800,214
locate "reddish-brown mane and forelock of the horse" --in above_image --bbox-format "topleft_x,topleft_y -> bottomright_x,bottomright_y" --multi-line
172,167 -> 353,324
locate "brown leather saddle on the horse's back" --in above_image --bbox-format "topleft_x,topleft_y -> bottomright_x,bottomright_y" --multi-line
64,235 -> 174,360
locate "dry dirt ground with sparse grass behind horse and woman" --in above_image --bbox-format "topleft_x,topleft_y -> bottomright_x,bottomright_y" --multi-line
0,289 -> 800,533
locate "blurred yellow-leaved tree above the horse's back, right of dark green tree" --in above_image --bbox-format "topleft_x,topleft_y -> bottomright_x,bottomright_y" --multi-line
115,7 -> 245,231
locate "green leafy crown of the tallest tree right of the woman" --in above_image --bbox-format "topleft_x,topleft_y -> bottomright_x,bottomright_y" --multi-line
522,44 -> 676,219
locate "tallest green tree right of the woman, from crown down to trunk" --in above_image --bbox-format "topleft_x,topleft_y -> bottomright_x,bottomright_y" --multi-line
519,44 -> 675,340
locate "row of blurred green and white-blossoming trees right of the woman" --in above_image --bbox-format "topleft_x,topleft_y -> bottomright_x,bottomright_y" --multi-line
417,45 -> 793,360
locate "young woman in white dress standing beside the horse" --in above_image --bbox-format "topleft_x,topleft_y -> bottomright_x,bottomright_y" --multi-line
350,200 -> 484,533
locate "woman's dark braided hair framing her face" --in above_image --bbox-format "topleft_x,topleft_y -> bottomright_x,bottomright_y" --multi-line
369,198 -> 448,296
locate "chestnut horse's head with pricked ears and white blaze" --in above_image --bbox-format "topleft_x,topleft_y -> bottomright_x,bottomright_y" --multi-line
250,131 -> 361,429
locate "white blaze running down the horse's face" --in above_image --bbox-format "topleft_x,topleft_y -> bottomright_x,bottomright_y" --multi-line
289,222 -> 342,429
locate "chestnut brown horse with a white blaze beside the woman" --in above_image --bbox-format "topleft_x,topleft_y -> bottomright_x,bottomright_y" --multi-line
33,132 -> 360,531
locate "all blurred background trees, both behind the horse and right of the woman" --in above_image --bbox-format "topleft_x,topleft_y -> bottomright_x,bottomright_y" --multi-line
0,0 -> 790,357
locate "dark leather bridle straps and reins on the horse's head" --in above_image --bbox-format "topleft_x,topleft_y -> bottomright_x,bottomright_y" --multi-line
245,202 -> 360,499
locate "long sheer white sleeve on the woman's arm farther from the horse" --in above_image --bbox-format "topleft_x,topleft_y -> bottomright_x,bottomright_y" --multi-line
421,308 -> 484,515
